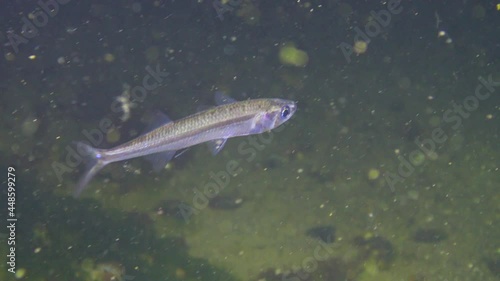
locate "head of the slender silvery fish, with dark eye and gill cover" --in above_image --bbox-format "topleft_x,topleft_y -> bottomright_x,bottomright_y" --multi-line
254,99 -> 297,132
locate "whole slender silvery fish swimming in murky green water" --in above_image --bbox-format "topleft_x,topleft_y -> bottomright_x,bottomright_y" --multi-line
73,92 -> 297,197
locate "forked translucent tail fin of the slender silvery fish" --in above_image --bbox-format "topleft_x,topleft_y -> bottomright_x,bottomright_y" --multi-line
73,142 -> 108,198
